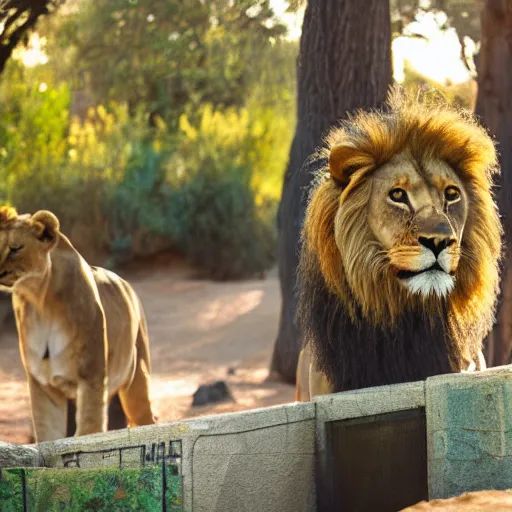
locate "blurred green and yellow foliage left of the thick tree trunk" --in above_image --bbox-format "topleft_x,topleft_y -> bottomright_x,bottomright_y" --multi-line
0,0 -> 298,279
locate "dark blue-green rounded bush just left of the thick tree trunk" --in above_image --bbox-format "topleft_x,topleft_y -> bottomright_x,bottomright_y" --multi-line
170,159 -> 275,280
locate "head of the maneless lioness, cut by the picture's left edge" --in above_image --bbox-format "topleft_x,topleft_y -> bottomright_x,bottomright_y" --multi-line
0,207 -> 59,290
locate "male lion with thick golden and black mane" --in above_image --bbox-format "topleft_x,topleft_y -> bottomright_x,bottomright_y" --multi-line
296,90 -> 501,400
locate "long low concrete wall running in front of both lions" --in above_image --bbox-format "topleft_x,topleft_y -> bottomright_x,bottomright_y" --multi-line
0,366 -> 512,512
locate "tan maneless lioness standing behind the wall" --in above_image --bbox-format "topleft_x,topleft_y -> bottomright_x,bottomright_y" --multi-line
0,207 -> 155,442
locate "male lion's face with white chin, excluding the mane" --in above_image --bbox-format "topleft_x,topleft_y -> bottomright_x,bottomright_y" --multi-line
368,152 -> 468,296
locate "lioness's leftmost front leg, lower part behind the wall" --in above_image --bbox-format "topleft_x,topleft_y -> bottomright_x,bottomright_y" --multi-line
28,375 -> 67,443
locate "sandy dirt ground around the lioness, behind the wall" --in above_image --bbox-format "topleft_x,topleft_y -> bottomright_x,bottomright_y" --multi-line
0,258 -> 294,443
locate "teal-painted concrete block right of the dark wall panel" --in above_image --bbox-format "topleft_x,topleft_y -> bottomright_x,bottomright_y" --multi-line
426,366 -> 512,498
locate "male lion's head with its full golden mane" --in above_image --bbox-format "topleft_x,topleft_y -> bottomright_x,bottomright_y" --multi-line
301,90 -> 501,321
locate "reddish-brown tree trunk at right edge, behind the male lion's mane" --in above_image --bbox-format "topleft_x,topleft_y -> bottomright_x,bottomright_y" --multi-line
475,0 -> 512,366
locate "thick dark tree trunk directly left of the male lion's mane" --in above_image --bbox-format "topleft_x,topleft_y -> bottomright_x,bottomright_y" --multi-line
271,0 -> 392,383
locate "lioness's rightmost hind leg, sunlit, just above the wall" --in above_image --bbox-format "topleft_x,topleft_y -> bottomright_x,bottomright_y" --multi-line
119,326 -> 155,427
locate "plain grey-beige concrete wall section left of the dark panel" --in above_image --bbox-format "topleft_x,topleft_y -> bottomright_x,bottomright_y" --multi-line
40,403 -> 315,512
